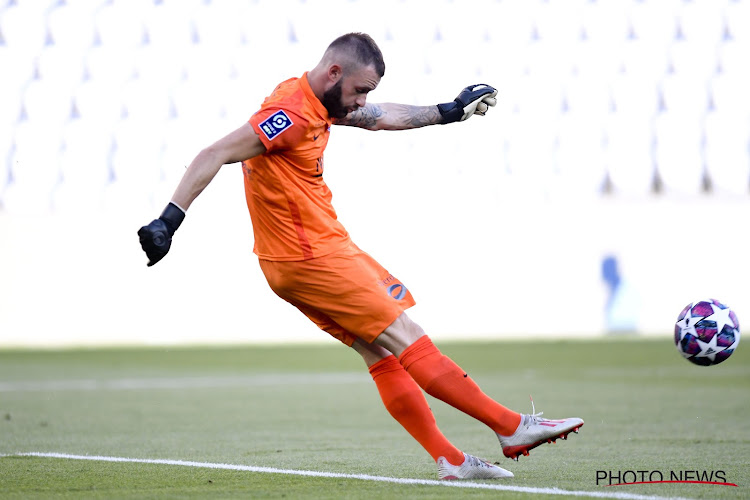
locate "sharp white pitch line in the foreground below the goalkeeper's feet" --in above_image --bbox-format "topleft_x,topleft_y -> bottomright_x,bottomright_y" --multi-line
0,452 -> 689,500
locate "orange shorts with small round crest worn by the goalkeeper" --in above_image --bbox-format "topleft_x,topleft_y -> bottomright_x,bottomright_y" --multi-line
260,244 -> 415,346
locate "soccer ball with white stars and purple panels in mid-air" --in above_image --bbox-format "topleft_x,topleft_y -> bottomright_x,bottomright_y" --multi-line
674,299 -> 740,366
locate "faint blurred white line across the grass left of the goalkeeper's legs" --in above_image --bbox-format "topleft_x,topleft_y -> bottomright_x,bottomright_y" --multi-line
0,372 -> 371,392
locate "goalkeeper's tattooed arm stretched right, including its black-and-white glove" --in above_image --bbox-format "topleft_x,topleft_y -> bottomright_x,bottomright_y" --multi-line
334,84 -> 497,130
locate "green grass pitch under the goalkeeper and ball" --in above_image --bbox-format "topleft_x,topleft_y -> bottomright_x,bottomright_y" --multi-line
0,337 -> 750,499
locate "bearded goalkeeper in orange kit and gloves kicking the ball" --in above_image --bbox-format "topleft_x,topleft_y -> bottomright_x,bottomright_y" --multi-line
138,33 -> 583,479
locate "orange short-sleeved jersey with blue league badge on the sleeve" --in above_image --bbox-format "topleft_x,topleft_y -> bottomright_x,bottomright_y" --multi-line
247,73 -> 351,261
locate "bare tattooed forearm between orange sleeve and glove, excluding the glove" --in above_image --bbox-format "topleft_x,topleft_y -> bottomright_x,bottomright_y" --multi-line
333,103 -> 442,130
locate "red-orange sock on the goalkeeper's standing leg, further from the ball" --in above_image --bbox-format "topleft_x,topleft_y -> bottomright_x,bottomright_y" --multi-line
370,356 -> 464,465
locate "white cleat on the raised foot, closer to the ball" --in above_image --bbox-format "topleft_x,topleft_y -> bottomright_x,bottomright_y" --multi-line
497,409 -> 583,460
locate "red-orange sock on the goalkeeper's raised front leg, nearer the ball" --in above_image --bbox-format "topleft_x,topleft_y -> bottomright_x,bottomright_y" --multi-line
399,335 -> 521,436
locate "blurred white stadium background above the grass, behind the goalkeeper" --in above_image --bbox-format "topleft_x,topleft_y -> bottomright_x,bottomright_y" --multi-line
0,0 -> 750,347
